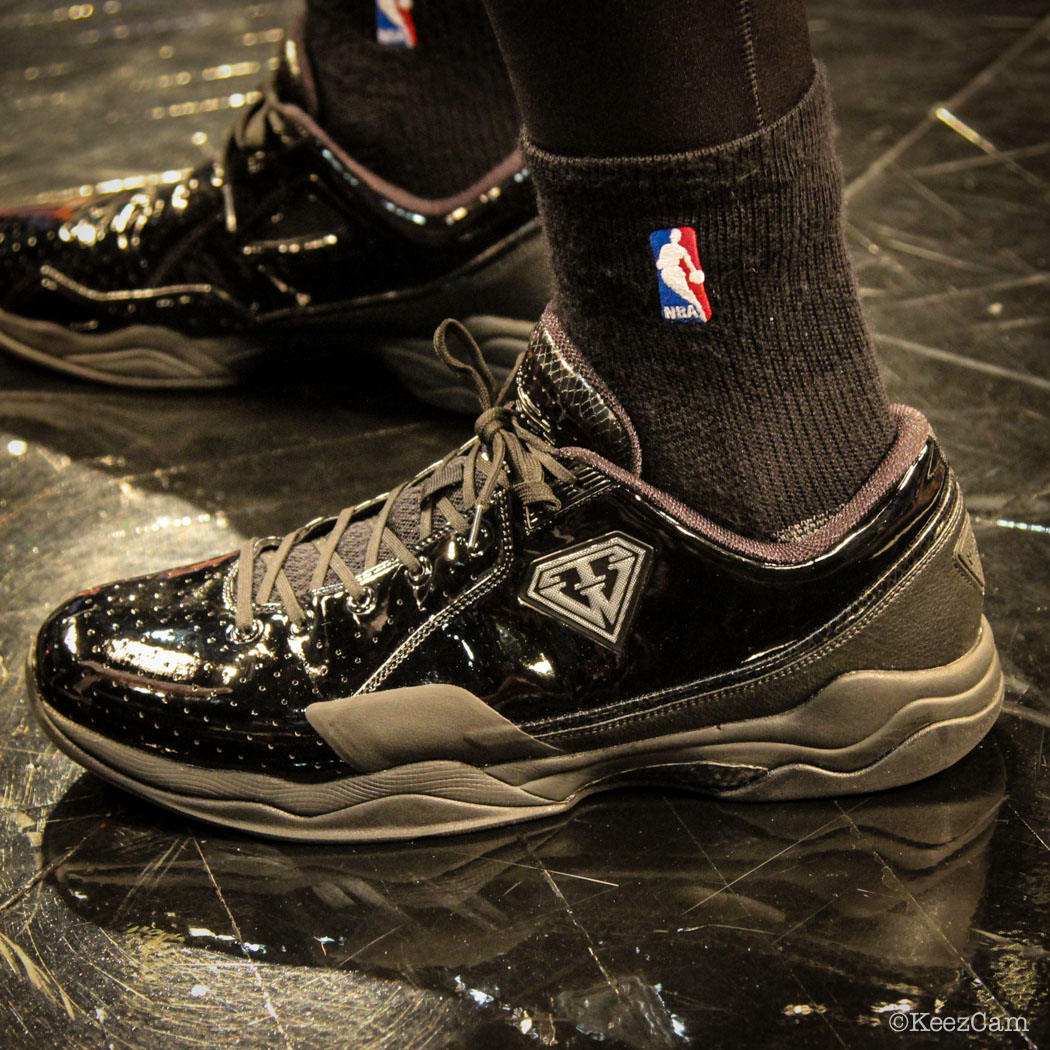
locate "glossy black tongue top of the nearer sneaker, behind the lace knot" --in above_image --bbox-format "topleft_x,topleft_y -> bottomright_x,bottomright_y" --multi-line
513,309 -> 642,474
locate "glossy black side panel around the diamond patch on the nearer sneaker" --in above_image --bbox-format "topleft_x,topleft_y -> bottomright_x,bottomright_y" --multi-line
382,442 -> 980,739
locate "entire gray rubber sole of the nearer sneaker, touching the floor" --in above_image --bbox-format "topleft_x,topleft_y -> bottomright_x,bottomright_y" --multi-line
27,622 -> 1004,842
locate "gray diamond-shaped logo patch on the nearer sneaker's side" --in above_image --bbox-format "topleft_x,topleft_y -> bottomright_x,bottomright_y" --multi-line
520,532 -> 653,652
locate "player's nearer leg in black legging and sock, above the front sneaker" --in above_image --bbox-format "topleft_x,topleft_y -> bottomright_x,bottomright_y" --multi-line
486,0 -> 894,537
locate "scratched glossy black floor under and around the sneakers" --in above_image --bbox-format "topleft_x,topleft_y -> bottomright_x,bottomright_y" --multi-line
0,0 -> 1050,1050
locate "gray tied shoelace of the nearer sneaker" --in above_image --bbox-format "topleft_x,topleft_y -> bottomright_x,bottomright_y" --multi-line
235,319 -> 572,632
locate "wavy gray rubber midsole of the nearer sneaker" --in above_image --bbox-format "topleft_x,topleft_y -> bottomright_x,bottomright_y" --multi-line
37,622 -> 1003,838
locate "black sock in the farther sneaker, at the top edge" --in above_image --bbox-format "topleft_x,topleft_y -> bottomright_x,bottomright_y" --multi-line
305,0 -> 519,197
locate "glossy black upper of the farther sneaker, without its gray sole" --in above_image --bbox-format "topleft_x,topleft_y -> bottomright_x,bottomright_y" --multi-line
0,51 -> 537,337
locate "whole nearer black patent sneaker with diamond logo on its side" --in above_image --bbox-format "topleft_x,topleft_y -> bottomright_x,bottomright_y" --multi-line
29,314 -> 1003,840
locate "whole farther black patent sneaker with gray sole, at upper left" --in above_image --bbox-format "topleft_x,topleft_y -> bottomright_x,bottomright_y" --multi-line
0,24 -> 549,410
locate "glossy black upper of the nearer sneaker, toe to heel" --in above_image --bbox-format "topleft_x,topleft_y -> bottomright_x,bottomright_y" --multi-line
36,375 -> 981,779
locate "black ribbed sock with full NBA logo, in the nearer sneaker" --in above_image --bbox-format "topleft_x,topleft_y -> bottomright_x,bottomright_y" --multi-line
526,72 -> 894,538
